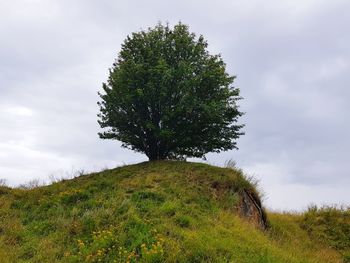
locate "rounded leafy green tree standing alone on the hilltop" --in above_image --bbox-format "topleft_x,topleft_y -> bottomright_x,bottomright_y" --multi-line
98,23 -> 243,160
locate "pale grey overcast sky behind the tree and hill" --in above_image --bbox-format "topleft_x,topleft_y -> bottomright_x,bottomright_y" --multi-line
0,0 -> 350,211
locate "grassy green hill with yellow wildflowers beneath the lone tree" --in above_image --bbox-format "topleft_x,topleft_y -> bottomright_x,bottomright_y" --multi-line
0,161 -> 350,263
